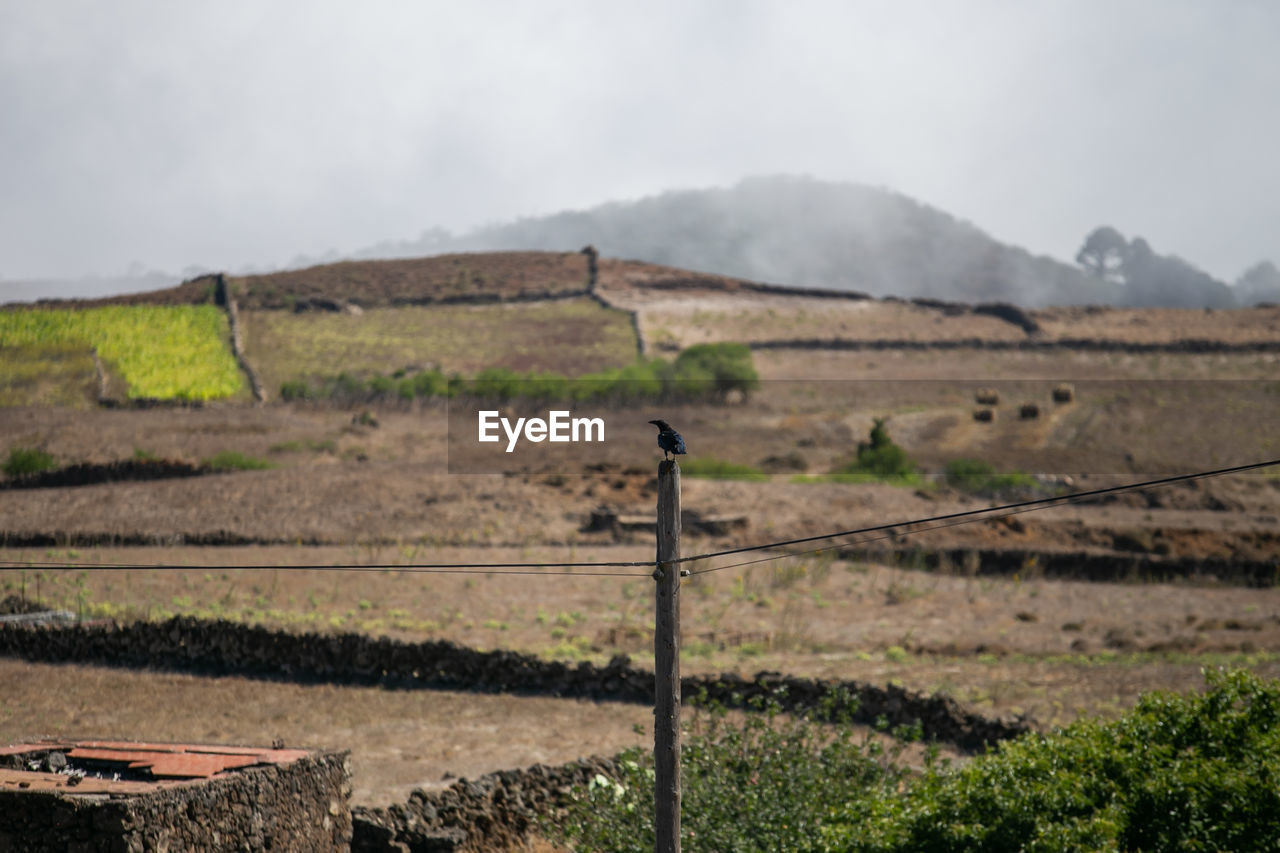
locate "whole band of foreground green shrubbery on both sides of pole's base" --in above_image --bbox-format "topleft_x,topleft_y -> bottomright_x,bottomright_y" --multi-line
559,670 -> 1280,853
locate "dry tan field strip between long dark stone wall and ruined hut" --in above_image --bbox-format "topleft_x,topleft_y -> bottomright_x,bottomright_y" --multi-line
0,658 -> 653,806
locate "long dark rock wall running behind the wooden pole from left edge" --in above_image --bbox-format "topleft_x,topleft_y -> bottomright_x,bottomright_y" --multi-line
0,616 -> 1030,751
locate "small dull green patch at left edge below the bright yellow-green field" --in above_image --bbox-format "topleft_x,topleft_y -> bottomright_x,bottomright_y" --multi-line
0,343 -> 97,407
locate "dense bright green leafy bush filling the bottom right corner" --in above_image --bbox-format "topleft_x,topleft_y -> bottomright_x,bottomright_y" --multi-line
818,671 -> 1280,852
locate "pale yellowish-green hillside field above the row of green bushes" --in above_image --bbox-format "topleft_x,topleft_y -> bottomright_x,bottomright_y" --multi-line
241,300 -> 636,388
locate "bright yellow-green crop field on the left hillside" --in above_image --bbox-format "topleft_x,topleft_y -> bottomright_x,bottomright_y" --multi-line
0,305 -> 244,400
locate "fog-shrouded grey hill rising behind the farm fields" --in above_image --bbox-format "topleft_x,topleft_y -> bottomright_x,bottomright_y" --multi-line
357,177 -> 1280,307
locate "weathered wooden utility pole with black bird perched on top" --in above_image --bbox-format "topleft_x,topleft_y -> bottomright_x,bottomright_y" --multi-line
653,460 -> 680,853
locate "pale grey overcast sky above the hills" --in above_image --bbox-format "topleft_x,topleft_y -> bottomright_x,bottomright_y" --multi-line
0,0 -> 1280,289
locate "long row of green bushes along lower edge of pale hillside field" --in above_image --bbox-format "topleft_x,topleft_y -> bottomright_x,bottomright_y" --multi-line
280,343 -> 759,403
